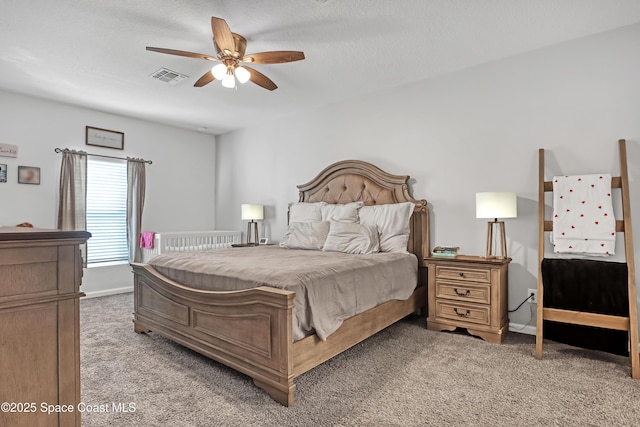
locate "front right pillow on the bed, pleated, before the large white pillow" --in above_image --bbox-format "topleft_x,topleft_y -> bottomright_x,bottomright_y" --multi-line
322,221 -> 380,254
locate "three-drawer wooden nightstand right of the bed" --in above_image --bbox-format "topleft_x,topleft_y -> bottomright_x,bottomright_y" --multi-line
424,255 -> 511,344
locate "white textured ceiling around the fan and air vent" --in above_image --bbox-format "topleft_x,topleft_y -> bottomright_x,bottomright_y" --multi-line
0,0 -> 640,134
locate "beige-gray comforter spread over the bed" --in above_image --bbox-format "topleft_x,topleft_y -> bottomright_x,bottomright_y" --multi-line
149,246 -> 418,341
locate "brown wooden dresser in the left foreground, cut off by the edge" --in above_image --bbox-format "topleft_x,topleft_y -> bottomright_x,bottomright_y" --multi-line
0,227 -> 90,427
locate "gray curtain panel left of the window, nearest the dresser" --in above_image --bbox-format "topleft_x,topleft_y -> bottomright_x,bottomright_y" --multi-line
58,149 -> 87,267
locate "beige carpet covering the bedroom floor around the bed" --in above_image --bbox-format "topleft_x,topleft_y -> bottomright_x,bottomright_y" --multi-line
81,294 -> 640,427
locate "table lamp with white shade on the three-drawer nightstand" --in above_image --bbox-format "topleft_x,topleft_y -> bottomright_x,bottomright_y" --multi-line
476,192 -> 518,258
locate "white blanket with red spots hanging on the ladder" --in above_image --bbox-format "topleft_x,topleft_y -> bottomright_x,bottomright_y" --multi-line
552,174 -> 616,255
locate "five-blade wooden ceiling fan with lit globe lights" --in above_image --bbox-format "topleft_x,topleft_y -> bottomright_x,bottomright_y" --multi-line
147,16 -> 304,90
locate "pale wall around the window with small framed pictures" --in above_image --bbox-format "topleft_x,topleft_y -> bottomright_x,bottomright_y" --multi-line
0,92 -> 215,295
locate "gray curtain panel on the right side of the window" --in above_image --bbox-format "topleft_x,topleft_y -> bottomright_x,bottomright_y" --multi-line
127,158 -> 146,262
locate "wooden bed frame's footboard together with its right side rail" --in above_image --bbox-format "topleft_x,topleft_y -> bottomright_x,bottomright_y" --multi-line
131,263 -> 426,406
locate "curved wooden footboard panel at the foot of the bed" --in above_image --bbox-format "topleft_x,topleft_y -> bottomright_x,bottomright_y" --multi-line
131,263 -> 295,406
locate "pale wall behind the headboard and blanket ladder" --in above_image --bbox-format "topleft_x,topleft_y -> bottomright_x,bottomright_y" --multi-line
216,25 -> 640,331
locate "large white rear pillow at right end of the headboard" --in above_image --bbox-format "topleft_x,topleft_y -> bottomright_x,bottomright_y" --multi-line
358,202 -> 415,253
